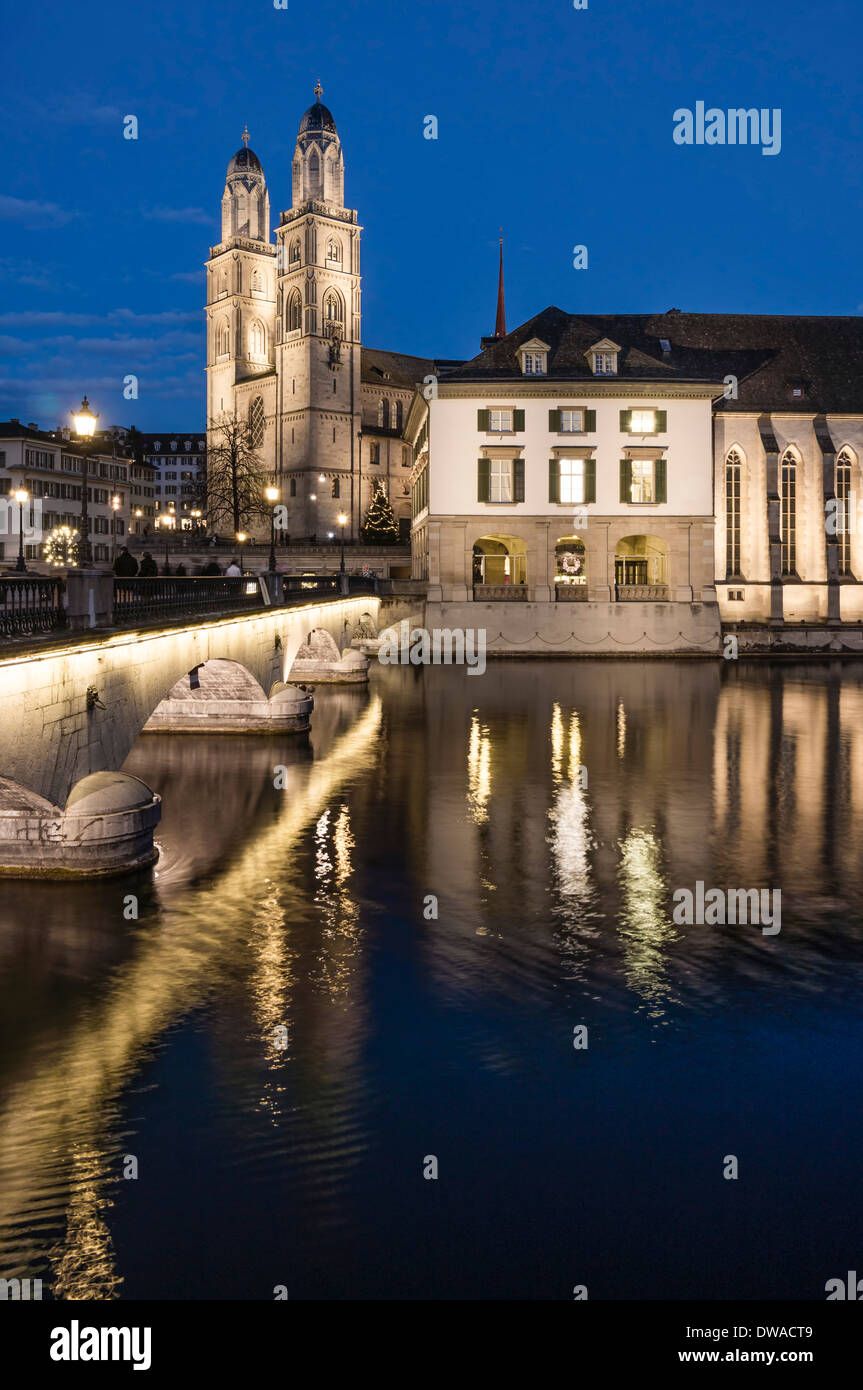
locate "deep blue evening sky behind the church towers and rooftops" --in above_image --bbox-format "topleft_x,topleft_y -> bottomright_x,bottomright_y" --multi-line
0,0 -> 863,430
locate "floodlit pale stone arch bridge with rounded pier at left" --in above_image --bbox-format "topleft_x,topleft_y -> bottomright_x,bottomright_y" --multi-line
0,595 -> 416,874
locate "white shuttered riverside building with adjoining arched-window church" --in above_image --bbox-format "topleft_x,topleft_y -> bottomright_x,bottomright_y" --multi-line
409,309 -> 863,623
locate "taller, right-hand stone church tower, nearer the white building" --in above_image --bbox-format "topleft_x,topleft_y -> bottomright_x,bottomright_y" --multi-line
275,83 -> 361,539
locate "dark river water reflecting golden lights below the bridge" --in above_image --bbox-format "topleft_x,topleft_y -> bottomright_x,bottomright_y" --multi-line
0,660 -> 863,1300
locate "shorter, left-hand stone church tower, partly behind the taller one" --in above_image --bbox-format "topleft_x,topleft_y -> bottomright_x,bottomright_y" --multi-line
207,129 -> 277,492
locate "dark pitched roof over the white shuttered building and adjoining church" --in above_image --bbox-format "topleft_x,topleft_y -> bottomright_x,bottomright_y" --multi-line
442,306 -> 863,414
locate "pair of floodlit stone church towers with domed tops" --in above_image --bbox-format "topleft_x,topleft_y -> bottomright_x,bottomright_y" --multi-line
207,83 -> 380,539
